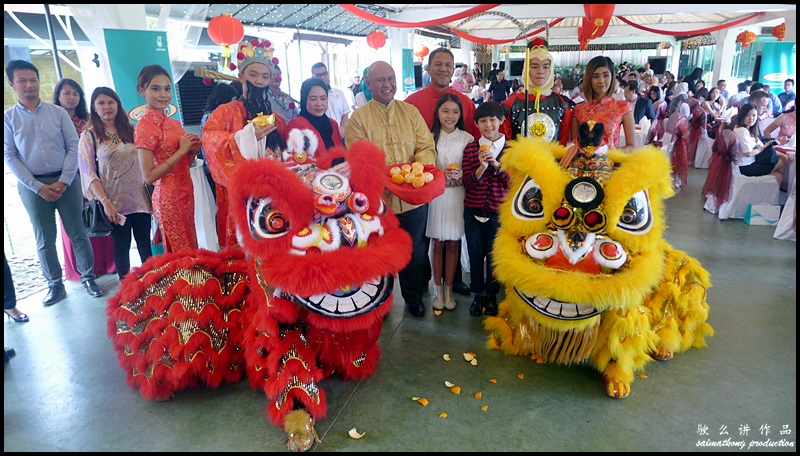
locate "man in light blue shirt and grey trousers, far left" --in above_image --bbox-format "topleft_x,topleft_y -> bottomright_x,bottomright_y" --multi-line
3,60 -> 105,306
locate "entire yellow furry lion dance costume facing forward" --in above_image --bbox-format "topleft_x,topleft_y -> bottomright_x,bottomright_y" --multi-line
484,130 -> 714,398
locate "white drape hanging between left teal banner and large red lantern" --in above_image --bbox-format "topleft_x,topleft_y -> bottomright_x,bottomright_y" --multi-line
156,3 -> 209,83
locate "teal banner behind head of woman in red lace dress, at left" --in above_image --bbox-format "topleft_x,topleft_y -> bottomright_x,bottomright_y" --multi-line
103,29 -> 182,122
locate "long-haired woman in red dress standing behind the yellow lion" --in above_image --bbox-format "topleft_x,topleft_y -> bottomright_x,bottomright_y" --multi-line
570,55 -> 636,150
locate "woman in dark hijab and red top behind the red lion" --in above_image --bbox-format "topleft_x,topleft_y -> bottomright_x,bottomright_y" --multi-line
286,78 -> 343,157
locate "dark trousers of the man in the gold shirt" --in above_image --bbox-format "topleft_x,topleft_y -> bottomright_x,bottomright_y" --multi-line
397,204 -> 430,303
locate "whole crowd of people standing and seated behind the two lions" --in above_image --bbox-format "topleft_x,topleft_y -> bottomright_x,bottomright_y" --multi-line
5,37 -> 795,322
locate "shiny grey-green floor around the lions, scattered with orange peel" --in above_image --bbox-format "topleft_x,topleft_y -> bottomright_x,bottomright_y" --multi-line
3,169 -> 797,452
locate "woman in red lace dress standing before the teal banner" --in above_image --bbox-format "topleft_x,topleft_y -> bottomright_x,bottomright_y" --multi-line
133,65 -> 200,253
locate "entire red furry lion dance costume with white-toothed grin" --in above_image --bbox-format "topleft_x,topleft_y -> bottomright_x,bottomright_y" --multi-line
107,141 -> 411,451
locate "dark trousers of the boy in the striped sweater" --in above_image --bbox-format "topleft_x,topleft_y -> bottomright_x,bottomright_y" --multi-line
464,207 -> 500,296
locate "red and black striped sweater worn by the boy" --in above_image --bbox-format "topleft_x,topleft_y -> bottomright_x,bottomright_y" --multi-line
461,136 -> 510,214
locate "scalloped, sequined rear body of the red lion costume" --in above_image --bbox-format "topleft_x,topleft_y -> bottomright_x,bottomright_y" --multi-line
106,250 -> 248,400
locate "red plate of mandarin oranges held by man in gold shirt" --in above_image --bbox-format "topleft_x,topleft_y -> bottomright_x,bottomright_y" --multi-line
386,162 -> 445,204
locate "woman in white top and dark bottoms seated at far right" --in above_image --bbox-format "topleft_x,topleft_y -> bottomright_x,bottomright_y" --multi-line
733,103 -> 789,185
